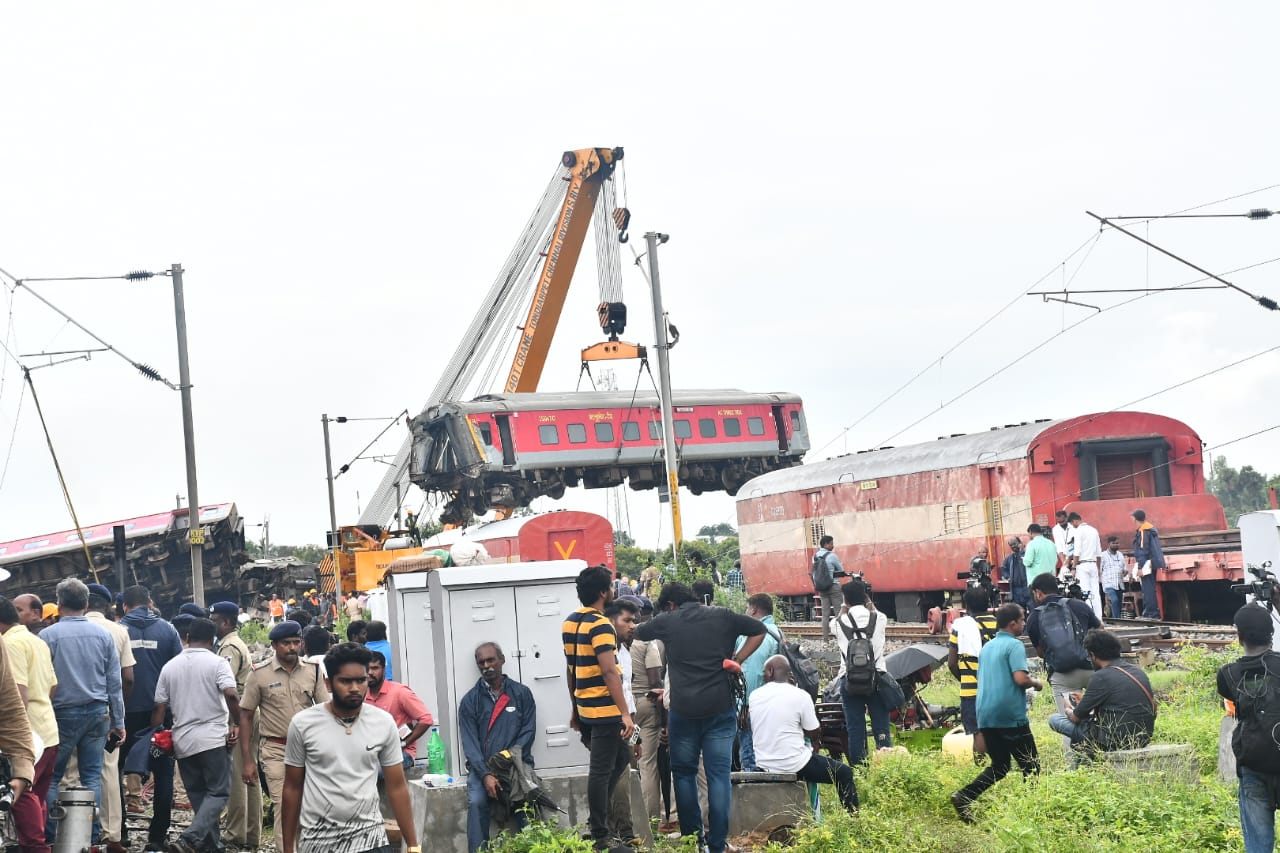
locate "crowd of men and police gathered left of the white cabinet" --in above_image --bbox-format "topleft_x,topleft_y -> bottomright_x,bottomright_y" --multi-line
0,578 -> 431,853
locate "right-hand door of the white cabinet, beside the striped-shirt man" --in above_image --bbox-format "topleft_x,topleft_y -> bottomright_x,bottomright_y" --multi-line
507,581 -> 589,770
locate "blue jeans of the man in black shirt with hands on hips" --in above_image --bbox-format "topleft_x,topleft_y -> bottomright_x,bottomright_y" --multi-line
668,708 -> 737,853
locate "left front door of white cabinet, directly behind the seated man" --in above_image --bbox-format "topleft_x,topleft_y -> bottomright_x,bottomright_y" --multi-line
445,587 -> 514,779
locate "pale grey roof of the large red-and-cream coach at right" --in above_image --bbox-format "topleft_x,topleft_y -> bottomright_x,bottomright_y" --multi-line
737,420 -> 1068,501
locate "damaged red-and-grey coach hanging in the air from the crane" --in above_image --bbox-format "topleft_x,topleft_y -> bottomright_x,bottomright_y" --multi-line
410,389 -> 809,523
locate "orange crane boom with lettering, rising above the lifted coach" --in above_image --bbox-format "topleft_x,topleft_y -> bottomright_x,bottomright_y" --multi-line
506,149 -> 622,394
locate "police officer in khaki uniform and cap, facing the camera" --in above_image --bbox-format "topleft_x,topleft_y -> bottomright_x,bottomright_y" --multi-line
241,621 -> 329,853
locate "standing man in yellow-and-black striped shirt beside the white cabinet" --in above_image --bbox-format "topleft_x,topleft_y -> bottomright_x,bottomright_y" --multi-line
561,566 -> 635,850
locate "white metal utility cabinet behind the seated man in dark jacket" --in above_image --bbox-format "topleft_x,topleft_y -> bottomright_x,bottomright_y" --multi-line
388,560 -> 589,779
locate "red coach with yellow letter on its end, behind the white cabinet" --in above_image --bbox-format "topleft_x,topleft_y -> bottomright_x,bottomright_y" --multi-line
422,510 -> 616,570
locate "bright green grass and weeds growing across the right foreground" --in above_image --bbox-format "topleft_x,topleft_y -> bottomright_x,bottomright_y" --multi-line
494,647 -> 1243,853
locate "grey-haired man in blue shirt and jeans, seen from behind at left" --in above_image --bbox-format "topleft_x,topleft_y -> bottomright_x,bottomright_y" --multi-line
40,578 -> 124,841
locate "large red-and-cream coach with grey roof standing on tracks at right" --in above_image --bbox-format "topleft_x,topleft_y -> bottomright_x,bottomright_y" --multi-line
737,412 -> 1240,621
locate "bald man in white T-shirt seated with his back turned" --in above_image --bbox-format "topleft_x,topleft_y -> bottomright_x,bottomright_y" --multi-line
750,654 -> 858,812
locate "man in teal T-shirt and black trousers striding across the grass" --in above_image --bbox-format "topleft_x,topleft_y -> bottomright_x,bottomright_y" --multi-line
951,603 -> 1044,824
